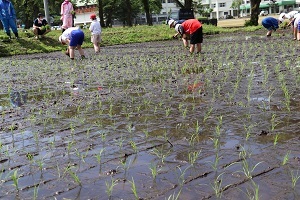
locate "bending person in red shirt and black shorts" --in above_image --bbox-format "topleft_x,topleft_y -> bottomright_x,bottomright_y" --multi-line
175,19 -> 203,53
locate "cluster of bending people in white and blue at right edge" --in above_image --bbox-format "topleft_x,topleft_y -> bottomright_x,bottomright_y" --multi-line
262,11 -> 300,41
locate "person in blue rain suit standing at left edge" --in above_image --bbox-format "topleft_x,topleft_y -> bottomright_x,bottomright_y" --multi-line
0,0 -> 19,39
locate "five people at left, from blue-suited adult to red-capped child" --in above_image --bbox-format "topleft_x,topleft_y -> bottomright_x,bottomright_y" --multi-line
0,0 -> 101,59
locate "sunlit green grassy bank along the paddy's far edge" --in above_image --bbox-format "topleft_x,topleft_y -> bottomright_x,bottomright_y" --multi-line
0,25 -> 261,57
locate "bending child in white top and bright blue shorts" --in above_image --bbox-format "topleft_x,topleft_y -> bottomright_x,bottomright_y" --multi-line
58,27 -> 85,60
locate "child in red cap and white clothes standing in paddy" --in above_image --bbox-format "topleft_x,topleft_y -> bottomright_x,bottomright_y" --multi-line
89,14 -> 101,53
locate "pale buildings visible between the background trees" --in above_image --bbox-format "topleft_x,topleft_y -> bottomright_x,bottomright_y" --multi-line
74,0 -> 300,25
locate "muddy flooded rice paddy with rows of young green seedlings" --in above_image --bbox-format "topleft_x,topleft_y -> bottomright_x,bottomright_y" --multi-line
0,31 -> 300,200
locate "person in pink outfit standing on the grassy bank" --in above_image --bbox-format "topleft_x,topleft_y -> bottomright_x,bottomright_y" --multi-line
60,0 -> 74,32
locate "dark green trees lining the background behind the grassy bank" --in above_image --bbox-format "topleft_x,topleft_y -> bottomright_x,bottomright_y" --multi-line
7,0 -> 261,28
